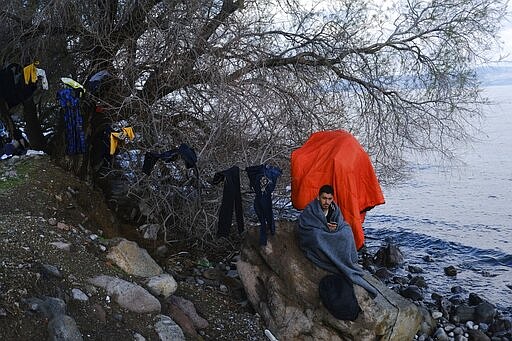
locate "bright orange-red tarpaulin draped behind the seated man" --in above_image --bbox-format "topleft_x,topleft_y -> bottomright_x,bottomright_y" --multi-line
291,130 -> 384,249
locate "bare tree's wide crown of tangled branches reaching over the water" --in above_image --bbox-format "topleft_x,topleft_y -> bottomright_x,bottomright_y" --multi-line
0,0 -> 506,239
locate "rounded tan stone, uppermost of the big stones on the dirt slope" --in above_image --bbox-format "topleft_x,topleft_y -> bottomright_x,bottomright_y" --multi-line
107,239 -> 163,277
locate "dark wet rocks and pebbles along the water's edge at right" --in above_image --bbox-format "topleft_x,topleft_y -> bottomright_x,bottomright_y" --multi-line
360,241 -> 512,341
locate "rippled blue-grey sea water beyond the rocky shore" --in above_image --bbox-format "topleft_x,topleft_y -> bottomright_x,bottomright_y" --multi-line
364,85 -> 512,312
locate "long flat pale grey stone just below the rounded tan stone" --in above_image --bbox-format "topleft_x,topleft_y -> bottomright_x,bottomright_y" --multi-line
89,275 -> 161,313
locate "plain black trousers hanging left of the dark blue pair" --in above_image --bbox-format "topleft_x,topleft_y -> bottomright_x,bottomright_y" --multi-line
212,166 -> 244,237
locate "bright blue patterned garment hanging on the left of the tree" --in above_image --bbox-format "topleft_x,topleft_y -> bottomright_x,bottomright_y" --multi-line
57,88 -> 86,155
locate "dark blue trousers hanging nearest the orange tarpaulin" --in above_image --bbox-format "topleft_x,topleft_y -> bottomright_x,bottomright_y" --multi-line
245,165 -> 282,245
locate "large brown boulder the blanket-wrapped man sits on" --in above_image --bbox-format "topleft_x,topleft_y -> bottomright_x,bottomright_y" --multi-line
237,222 -> 421,341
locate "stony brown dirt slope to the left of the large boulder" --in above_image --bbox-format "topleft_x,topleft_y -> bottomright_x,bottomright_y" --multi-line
0,156 -> 266,340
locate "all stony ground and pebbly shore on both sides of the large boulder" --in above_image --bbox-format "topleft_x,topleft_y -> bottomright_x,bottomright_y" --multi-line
0,155 -> 512,341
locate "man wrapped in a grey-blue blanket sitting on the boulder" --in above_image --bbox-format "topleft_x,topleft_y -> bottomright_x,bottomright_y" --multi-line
297,185 -> 377,297
